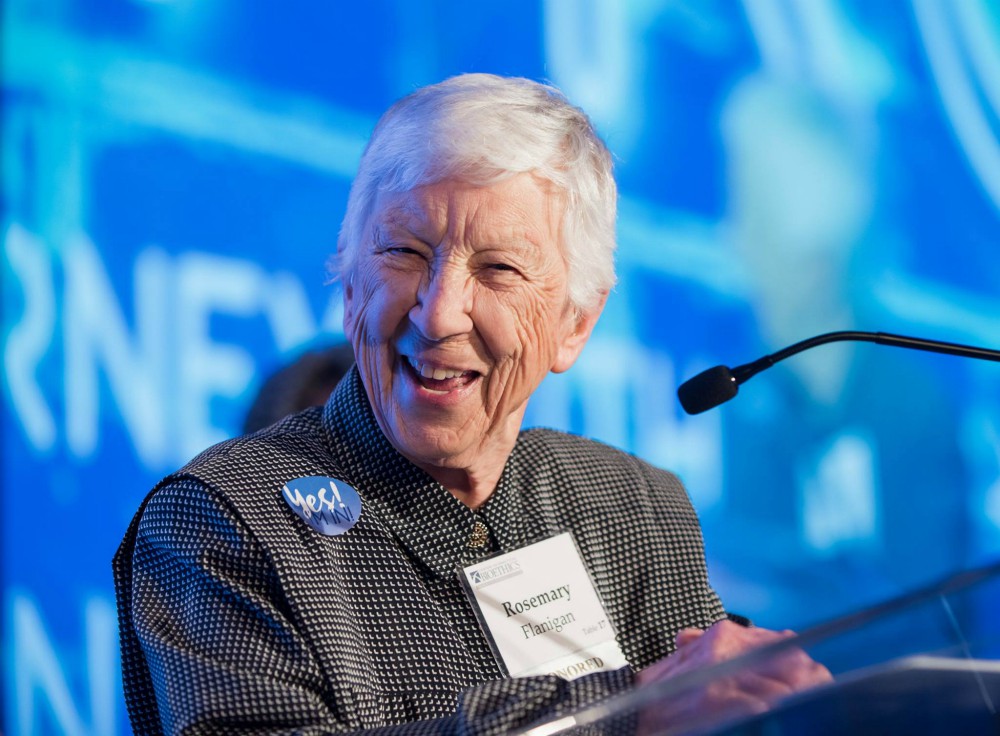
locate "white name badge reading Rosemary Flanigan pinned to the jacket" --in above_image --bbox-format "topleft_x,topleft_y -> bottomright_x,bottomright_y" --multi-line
462,532 -> 628,680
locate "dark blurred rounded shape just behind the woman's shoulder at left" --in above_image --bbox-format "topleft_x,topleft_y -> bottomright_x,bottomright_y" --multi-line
243,343 -> 354,434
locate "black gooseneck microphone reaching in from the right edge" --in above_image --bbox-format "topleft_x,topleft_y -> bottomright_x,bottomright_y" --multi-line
677,331 -> 1000,414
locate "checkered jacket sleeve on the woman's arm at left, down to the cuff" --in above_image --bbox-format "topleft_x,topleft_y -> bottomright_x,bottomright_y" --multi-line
114,478 -> 633,736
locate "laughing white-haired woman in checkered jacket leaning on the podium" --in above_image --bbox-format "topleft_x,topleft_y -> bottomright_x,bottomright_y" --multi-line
115,70 -> 825,734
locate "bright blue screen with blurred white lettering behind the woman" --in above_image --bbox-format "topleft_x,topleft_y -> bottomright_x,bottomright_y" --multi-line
0,0 -> 1000,735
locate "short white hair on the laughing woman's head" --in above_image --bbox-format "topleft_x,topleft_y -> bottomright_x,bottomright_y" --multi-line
331,74 -> 617,310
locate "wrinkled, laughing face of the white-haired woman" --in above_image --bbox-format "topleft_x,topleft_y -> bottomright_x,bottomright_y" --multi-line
342,174 -> 600,475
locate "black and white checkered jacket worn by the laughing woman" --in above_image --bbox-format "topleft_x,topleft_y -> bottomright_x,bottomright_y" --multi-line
114,372 -> 725,735
